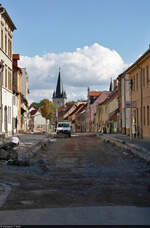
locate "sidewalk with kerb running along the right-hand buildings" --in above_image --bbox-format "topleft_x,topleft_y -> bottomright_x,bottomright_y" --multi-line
98,133 -> 150,162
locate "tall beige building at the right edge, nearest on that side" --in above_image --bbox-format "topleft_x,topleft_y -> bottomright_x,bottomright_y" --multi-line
118,49 -> 150,137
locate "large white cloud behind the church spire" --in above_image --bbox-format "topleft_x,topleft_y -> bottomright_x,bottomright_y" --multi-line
19,43 -> 127,101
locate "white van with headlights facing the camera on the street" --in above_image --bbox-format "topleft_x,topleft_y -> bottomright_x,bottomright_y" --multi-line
56,122 -> 71,137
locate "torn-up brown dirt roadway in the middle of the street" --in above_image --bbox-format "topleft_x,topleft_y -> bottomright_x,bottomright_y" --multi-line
0,135 -> 150,210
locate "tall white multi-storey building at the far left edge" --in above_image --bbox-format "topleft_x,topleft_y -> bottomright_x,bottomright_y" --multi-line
0,5 -> 16,134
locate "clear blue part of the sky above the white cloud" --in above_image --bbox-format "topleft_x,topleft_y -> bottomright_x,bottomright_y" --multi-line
1,0 -> 150,101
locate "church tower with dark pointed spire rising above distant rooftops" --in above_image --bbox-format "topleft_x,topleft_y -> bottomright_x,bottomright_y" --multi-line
53,68 -> 67,107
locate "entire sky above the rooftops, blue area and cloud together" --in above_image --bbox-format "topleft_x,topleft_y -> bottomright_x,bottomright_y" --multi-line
0,0 -> 150,102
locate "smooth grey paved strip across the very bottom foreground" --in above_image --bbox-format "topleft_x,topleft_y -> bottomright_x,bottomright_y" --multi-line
0,206 -> 150,226
